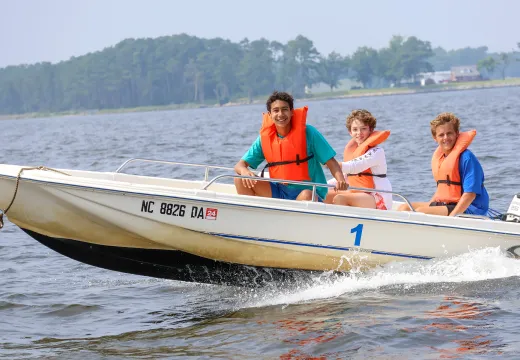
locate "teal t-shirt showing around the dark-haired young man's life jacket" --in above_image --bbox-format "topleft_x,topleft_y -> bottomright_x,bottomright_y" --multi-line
242,125 -> 336,199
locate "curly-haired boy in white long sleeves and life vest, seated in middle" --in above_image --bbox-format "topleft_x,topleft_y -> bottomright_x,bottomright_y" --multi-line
325,109 -> 392,210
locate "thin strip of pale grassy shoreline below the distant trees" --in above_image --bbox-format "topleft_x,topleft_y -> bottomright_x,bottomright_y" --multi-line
0,78 -> 520,120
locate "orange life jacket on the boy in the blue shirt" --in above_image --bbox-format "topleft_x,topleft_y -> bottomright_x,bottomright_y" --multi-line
432,130 -> 477,203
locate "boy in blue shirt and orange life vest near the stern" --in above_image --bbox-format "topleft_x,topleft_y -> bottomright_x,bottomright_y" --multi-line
399,112 -> 489,216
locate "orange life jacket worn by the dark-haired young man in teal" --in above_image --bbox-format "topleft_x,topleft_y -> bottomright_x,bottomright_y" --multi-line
260,106 -> 314,181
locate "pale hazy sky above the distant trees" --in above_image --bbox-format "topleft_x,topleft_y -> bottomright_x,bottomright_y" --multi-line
0,0 -> 520,67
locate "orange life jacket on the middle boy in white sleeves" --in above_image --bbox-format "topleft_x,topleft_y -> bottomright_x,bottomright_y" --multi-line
343,130 -> 390,191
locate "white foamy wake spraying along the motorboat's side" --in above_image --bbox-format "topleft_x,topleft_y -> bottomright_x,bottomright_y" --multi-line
242,247 -> 520,307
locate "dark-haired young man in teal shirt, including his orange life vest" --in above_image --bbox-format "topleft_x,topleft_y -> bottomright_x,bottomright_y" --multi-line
235,91 -> 347,201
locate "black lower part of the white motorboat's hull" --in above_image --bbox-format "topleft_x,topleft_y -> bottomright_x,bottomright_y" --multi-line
22,228 -> 320,287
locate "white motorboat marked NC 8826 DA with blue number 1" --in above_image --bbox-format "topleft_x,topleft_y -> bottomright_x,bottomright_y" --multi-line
0,159 -> 520,286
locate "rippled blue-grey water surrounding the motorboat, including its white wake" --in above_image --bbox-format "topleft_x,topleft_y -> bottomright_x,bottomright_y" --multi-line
0,88 -> 520,359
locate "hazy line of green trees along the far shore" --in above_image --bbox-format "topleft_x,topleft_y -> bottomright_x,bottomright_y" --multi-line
0,34 -> 520,114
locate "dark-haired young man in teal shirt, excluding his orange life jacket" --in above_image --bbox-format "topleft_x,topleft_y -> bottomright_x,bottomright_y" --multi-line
235,91 -> 348,201
